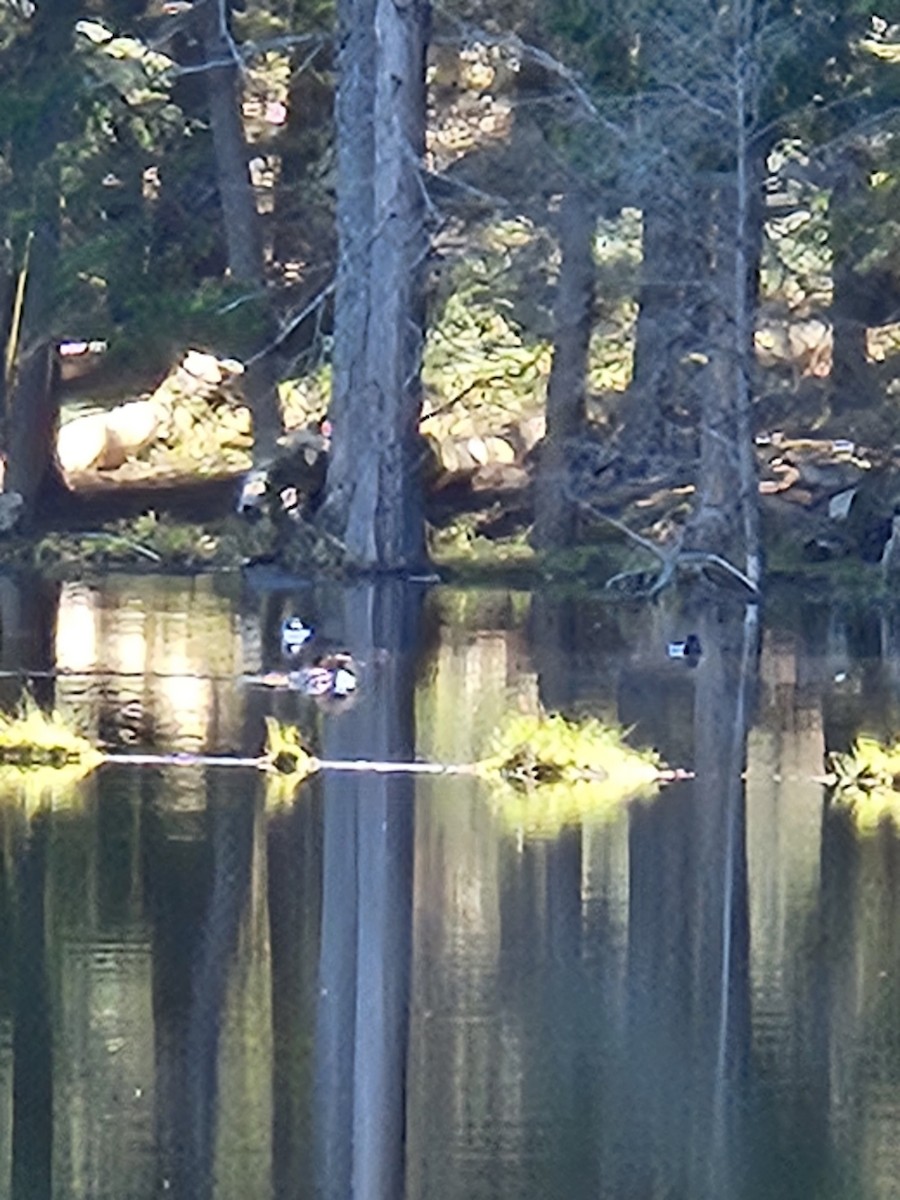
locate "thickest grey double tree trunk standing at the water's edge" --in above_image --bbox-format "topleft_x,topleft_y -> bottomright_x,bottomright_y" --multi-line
328,0 -> 427,571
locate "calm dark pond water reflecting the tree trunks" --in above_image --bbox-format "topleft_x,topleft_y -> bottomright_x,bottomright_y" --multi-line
0,578 -> 900,1200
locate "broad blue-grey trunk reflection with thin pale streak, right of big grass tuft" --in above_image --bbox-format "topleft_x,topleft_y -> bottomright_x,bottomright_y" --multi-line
622,608 -> 756,1200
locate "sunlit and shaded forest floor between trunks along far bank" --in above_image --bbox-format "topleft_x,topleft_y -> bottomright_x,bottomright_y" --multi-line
17,352 -> 900,578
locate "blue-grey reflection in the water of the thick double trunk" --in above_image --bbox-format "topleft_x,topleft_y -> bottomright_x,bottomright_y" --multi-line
316,583 -> 420,1200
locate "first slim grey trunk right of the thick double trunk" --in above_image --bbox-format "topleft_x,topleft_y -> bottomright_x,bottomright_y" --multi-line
534,188 -> 595,550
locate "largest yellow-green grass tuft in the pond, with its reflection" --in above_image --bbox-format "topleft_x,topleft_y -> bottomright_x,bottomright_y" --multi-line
476,714 -> 665,836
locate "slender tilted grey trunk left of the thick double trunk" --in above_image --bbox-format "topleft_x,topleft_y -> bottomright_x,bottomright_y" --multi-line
197,0 -> 283,461
